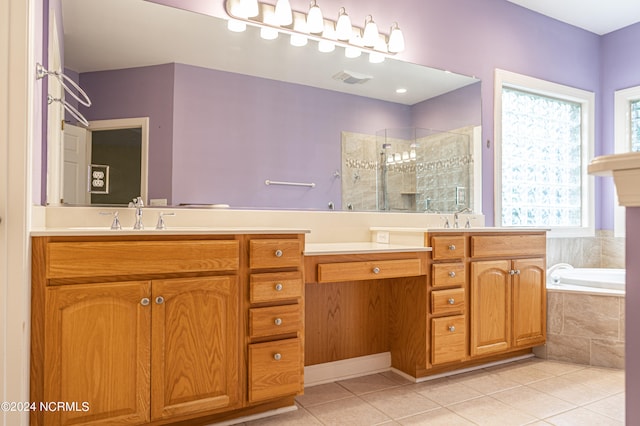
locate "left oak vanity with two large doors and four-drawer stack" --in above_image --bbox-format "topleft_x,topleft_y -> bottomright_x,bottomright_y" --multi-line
31,229 -> 304,425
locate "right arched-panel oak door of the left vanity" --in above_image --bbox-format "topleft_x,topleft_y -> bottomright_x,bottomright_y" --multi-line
151,276 -> 242,420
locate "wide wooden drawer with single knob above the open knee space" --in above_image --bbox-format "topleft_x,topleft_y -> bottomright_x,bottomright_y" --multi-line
318,259 -> 424,283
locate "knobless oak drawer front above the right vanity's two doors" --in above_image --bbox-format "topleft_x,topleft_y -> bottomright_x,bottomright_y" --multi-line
471,234 -> 547,257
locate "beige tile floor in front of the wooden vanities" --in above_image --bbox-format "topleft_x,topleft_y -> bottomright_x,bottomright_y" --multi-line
245,358 -> 625,426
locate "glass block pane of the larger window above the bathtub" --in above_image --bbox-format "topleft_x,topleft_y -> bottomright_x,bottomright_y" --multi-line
501,86 -> 584,227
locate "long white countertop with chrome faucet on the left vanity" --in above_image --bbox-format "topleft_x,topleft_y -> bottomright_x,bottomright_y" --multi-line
31,226 -> 310,237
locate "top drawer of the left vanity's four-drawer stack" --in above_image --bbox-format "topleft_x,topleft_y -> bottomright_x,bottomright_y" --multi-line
249,239 -> 302,269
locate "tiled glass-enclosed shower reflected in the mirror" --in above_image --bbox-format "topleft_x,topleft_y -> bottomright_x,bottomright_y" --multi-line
341,127 -> 477,213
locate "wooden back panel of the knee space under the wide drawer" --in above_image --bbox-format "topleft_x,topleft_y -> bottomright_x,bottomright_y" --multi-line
305,280 -> 395,365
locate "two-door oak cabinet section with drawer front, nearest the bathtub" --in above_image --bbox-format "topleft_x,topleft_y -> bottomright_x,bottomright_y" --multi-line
470,235 -> 546,357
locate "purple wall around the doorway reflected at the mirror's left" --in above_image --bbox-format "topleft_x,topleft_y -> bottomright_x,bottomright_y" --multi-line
80,64 -> 174,200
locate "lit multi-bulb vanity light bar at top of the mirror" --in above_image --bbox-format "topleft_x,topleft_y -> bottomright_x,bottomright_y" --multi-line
224,0 -> 404,58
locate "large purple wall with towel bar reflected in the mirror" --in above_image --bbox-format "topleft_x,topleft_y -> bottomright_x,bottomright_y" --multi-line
173,64 -> 411,209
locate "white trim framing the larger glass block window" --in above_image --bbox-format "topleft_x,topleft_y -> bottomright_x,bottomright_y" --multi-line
493,68 -> 595,238
